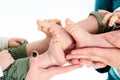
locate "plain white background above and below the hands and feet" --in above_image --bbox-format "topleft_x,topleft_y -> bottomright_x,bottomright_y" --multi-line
0,0 -> 107,80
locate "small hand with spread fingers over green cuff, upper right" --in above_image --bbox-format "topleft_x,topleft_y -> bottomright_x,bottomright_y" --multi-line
98,10 -> 120,26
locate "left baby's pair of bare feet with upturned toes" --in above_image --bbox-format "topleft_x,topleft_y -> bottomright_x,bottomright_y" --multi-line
37,20 -> 73,68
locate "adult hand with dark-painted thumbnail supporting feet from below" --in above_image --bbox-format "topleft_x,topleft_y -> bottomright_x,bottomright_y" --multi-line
25,52 -> 79,80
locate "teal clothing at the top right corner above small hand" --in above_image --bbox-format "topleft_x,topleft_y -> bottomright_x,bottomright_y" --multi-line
95,0 -> 120,12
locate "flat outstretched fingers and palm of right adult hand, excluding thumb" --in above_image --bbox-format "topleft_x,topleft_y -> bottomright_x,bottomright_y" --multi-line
66,48 -> 120,68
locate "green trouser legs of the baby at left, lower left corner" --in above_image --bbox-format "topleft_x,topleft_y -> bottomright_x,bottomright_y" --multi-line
0,43 -> 29,80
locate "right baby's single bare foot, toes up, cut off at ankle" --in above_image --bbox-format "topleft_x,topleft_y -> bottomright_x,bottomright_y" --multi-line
65,19 -> 91,48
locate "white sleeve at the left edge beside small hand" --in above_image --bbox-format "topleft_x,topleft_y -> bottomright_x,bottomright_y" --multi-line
0,36 -> 9,51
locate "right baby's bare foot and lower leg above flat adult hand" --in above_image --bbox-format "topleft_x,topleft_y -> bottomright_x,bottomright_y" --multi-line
65,19 -> 120,48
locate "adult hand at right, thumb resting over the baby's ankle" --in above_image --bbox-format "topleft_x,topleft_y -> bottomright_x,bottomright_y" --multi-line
67,33 -> 120,68
